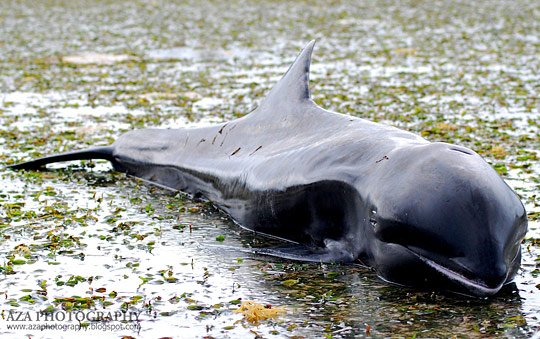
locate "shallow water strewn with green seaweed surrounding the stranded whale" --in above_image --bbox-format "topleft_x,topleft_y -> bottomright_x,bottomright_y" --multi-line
0,0 -> 540,338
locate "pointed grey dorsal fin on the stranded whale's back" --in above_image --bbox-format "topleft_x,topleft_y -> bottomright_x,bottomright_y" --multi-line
259,40 -> 315,110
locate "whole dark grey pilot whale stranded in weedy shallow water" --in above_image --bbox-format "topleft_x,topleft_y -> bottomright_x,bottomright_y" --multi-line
11,41 -> 527,297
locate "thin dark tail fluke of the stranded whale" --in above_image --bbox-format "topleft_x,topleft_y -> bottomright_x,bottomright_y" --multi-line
7,146 -> 114,170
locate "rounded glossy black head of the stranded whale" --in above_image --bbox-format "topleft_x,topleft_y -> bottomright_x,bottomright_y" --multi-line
369,143 -> 527,297
